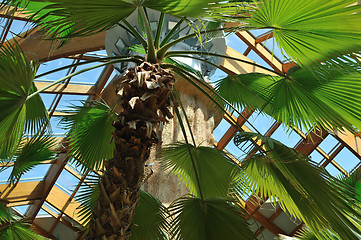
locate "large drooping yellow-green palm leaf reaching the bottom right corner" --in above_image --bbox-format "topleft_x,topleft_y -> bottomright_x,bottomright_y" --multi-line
235,133 -> 361,240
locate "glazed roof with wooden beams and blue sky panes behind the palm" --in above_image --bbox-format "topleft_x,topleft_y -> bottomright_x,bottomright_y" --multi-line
0,5 -> 361,240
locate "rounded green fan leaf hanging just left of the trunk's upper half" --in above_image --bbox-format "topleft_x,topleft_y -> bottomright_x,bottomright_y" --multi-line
62,102 -> 116,170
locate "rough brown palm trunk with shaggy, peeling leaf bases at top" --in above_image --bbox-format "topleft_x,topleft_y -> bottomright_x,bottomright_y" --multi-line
86,63 -> 175,240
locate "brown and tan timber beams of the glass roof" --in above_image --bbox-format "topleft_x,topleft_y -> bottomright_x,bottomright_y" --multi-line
0,7 -> 361,239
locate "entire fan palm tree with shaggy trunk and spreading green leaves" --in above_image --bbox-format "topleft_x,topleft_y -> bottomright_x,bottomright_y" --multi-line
0,0 -> 361,239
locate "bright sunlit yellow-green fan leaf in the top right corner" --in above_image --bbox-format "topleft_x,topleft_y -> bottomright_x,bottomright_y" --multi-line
247,0 -> 361,64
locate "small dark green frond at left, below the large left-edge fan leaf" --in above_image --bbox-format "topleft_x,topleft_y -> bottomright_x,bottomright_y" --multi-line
8,136 -> 56,184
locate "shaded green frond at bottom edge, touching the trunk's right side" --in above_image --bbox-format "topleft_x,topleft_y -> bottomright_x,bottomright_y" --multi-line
130,191 -> 169,240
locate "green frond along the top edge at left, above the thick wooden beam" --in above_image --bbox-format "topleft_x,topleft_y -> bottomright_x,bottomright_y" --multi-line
13,0 -> 136,38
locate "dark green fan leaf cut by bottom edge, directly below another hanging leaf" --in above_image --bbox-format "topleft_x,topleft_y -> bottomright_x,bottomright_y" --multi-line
169,197 -> 254,240
